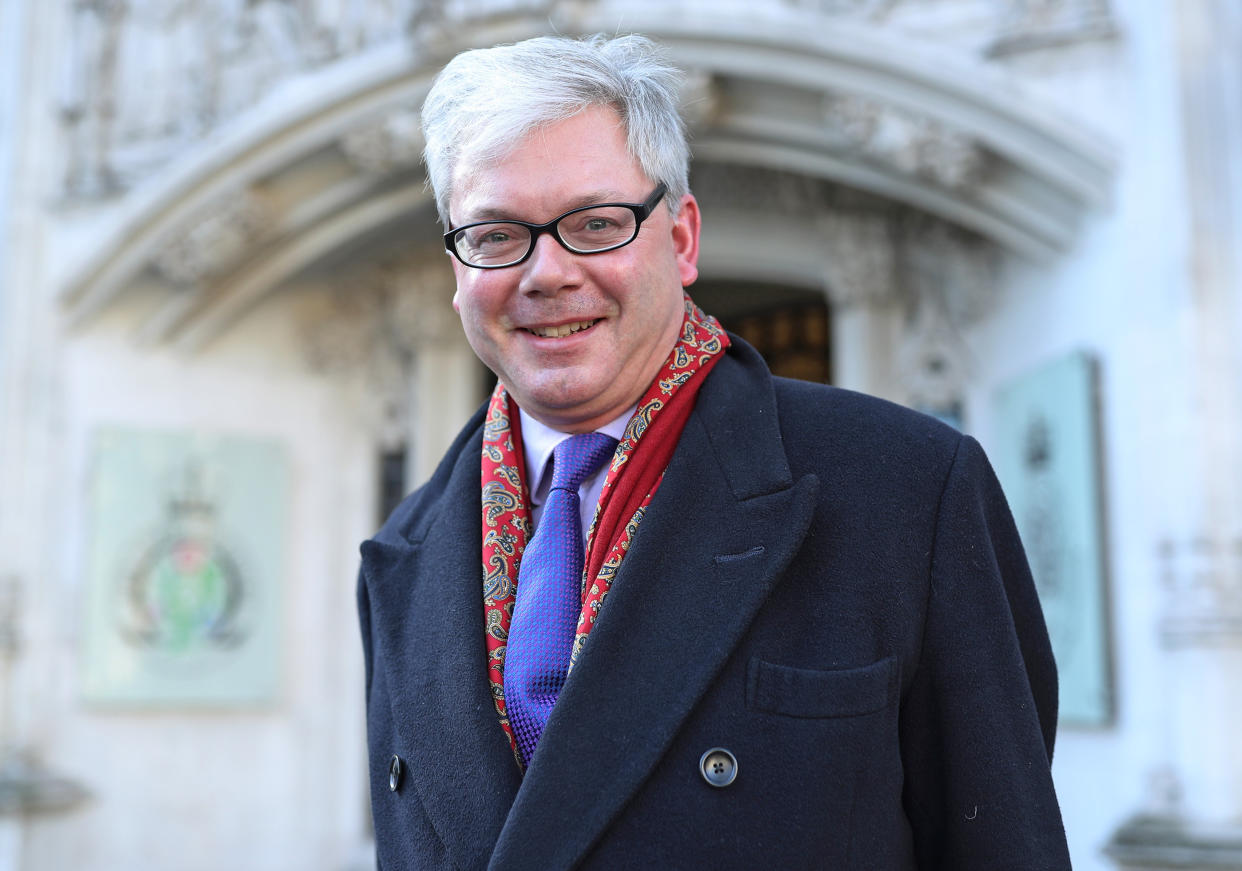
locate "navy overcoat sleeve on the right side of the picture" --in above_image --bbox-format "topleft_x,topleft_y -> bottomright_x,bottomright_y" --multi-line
900,436 -> 1069,871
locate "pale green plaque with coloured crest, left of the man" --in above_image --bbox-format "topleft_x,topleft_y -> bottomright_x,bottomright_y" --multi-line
83,429 -> 288,707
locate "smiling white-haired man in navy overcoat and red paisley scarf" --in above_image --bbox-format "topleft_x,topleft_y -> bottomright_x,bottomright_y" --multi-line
359,37 -> 1069,871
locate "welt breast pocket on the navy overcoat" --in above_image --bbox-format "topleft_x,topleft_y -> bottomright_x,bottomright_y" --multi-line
746,656 -> 897,718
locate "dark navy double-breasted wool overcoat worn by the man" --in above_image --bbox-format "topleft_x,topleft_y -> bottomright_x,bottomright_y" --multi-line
358,340 -> 1069,871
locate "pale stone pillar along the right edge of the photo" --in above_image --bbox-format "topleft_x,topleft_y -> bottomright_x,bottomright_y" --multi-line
1108,0 -> 1242,871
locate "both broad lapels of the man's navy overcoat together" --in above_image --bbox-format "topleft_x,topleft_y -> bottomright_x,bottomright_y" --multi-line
363,339 -> 818,869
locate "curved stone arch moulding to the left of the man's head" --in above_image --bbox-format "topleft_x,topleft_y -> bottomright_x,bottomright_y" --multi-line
61,40 -> 435,344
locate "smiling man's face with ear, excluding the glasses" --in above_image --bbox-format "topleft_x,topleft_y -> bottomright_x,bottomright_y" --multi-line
450,107 -> 699,432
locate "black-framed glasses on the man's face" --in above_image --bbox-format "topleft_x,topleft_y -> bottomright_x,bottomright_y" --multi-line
445,183 -> 668,270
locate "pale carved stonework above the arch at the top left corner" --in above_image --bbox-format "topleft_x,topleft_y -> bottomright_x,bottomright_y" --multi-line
58,0 -> 420,196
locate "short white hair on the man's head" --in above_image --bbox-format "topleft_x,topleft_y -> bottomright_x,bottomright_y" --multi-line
422,34 -> 689,226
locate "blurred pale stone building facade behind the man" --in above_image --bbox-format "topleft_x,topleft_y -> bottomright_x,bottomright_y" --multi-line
0,0 -> 1242,871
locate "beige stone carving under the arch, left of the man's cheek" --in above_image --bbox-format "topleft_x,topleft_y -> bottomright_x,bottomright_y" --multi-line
299,252 -> 461,449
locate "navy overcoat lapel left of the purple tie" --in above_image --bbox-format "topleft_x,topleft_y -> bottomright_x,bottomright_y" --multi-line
363,437 -> 520,869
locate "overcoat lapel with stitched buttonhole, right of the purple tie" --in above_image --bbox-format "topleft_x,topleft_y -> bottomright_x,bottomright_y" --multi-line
491,347 -> 818,869
